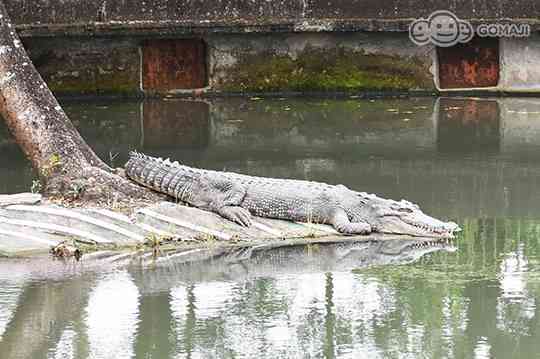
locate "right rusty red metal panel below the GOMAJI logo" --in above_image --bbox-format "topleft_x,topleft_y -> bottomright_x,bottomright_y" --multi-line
437,37 -> 500,89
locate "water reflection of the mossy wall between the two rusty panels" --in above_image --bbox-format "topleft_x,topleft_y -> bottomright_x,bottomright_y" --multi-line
212,99 -> 435,157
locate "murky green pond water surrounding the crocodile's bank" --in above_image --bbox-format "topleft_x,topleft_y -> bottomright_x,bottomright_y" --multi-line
0,98 -> 540,358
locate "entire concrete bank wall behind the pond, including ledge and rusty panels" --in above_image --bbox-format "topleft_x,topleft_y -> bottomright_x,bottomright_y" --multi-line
2,0 -> 540,96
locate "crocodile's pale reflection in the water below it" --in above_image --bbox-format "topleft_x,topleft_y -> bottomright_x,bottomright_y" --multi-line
127,236 -> 457,292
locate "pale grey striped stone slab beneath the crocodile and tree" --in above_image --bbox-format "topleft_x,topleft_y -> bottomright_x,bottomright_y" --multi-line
0,194 -> 346,255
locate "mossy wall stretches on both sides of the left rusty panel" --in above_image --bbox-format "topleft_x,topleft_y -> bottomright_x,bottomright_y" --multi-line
24,33 -> 434,96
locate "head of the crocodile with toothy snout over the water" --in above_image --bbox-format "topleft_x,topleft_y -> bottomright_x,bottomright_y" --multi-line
354,194 -> 461,238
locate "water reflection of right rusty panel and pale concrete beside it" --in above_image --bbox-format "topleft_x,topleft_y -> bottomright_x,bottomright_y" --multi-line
434,98 -> 540,161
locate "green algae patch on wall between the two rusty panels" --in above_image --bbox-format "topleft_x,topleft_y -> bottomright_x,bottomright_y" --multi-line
215,48 -> 433,92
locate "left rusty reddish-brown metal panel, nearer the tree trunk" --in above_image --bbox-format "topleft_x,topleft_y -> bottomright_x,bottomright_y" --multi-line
142,39 -> 208,91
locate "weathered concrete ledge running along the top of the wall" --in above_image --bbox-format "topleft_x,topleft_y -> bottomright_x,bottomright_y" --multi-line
5,0 -> 540,36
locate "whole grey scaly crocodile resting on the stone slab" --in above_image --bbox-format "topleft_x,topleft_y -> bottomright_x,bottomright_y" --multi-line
125,152 -> 460,238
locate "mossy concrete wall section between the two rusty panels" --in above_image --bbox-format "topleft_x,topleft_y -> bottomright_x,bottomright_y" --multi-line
208,33 -> 434,92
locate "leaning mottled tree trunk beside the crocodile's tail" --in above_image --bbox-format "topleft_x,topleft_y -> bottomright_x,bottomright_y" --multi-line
0,0 -> 155,199
